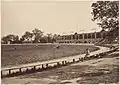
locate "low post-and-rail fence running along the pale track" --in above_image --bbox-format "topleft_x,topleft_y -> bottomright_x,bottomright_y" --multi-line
1,48 -> 118,78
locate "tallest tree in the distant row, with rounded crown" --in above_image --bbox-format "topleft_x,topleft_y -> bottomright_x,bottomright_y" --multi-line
32,28 -> 43,43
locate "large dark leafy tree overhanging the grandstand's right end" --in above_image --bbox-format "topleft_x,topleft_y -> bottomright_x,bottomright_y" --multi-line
91,1 -> 119,39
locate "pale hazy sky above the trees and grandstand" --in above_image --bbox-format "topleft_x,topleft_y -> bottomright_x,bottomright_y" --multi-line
1,1 -> 100,36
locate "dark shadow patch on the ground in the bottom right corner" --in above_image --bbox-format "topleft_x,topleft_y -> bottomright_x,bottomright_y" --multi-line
77,65 -> 119,84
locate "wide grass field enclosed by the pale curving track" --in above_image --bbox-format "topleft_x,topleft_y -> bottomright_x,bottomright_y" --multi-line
1,45 -> 98,67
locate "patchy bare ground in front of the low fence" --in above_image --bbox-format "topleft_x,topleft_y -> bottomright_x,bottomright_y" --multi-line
2,51 -> 119,84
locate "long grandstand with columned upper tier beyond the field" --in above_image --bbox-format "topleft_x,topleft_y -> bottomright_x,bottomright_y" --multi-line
56,30 -> 107,43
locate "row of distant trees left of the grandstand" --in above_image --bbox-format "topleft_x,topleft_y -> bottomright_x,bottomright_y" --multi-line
1,28 -> 59,44
